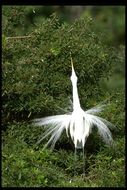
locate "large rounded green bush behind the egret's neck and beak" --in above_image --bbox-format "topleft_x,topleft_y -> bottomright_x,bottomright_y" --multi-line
2,8 -> 116,124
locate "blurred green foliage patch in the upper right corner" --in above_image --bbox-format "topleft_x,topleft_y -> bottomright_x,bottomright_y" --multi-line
83,6 -> 125,46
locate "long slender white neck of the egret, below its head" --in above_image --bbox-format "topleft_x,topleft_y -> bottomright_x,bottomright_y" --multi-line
72,82 -> 80,110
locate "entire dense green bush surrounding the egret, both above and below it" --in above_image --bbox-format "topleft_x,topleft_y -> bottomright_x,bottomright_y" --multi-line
2,7 -> 125,187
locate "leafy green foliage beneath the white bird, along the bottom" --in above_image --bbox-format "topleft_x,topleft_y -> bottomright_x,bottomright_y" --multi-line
2,117 -> 125,187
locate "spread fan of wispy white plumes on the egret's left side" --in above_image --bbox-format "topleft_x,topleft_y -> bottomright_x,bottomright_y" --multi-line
33,114 -> 71,148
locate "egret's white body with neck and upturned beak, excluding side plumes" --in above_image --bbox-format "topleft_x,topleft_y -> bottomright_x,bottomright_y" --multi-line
70,58 -> 89,149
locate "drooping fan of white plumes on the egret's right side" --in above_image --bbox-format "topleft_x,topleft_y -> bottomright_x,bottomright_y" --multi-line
84,113 -> 114,144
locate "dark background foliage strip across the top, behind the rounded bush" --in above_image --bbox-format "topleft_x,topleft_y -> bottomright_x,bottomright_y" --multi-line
2,6 -> 125,46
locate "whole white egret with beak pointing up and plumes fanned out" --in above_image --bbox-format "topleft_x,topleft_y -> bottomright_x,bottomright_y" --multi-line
33,57 -> 114,153
